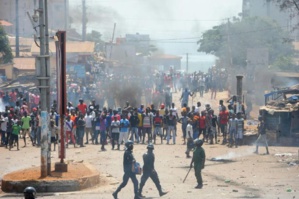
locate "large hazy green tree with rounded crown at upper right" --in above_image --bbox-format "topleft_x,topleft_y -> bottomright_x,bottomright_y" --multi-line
198,17 -> 294,66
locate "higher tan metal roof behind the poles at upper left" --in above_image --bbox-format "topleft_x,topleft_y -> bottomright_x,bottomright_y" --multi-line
31,41 -> 95,54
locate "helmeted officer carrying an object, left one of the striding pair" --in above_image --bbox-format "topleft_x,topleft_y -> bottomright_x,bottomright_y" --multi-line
112,140 -> 140,199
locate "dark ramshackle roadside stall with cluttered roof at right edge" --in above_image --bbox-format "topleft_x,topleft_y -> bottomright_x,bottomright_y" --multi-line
259,84 -> 299,146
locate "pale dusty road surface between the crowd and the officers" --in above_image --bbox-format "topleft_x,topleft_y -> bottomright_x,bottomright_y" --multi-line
0,93 -> 299,199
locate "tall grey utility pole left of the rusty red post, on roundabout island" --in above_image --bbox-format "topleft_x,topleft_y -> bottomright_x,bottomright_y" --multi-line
36,0 -> 51,177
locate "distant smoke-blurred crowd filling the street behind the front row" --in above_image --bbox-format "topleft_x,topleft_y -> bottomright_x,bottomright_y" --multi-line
60,67 -> 228,108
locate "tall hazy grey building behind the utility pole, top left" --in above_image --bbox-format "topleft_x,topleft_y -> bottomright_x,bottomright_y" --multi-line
0,0 -> 69,37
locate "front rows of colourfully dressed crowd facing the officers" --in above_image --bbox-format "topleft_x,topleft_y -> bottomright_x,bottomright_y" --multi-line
0,87 -> 244,154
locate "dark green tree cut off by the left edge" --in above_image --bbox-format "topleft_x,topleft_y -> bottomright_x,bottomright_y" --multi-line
0,25 -> 13,64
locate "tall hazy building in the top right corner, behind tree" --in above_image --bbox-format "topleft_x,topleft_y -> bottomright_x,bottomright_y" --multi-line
242,0 -> 299,41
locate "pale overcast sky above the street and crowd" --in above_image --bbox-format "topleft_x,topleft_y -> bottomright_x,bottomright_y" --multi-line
69,0 -> 242,54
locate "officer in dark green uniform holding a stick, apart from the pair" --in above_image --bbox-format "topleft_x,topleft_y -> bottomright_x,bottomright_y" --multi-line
190,139 -> 206,189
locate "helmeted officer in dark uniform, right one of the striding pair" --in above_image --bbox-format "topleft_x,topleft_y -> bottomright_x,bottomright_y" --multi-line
139,143 -> 167,197
